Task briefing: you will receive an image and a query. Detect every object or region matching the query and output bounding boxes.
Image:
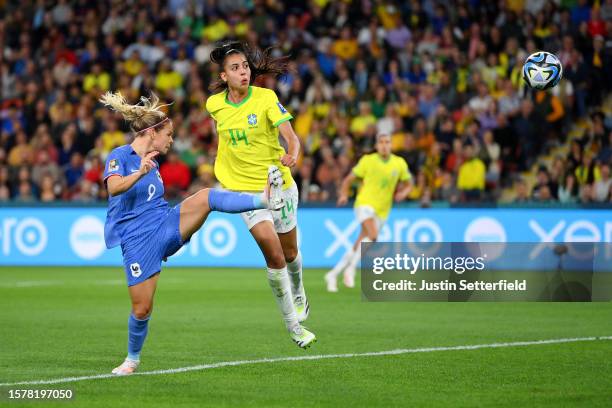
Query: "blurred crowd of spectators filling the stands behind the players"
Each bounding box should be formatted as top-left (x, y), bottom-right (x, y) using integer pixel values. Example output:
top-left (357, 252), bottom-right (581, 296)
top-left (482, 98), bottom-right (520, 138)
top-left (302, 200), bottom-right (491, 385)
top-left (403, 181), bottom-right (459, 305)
top-left (0, 0), bottom-right (612, 205)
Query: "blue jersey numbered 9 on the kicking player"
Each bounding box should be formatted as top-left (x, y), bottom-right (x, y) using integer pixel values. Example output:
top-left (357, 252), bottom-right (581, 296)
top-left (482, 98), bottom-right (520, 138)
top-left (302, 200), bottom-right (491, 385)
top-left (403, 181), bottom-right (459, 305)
top-left (104, 145), bottom-right (169, 248)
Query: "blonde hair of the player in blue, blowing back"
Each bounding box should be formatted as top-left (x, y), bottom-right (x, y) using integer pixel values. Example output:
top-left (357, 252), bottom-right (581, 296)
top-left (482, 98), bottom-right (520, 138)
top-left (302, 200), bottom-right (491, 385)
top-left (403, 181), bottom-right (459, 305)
top-left (100, 92), bottom-right (169, 133)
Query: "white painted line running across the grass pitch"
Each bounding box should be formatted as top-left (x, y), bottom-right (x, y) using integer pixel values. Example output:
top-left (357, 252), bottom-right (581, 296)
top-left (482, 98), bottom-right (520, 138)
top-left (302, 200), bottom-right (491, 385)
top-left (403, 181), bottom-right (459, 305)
top-left (0, 336), bottom-right (612, 387)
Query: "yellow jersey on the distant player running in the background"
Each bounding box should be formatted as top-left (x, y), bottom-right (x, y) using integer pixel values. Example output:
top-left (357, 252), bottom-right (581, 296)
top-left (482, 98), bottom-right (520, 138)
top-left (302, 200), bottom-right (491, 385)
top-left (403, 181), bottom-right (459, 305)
top-left (353, 153), bottom-right (412, 219)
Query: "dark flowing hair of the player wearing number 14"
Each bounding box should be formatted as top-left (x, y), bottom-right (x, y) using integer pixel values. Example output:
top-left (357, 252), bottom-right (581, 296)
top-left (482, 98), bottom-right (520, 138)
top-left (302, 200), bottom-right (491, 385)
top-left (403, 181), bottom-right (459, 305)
top-left (208, 41), bottom-right (289, 93)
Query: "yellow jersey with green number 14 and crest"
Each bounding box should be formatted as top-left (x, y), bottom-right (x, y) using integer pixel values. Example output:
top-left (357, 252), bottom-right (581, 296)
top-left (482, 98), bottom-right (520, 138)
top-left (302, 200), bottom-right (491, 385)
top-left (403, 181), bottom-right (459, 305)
top-left (206, 86), bottom-right (294, 191)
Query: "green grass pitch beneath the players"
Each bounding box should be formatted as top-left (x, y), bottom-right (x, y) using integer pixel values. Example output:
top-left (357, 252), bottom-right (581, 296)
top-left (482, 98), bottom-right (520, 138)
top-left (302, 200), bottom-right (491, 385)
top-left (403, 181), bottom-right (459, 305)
top-left (0, 268), bottom-right (612, 407)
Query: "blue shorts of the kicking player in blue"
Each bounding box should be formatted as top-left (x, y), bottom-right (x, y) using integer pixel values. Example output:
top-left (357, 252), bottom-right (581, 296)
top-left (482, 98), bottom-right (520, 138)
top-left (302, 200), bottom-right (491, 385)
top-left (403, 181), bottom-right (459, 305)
top-left (121, 204), bottom-right (185, 286)
